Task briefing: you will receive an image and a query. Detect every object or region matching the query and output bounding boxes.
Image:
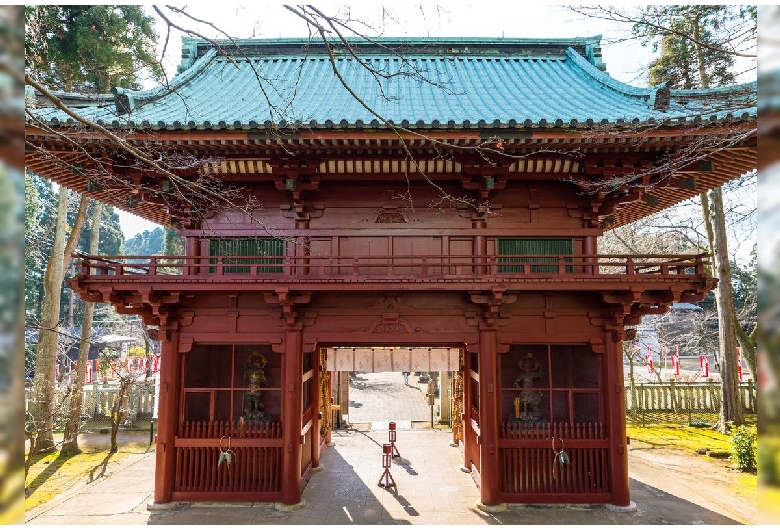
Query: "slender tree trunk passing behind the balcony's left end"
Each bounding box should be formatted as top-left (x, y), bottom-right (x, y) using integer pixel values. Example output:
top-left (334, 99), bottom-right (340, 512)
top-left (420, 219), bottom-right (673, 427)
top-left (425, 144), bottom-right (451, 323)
top-left (61, 202), bottom-right (103, 453)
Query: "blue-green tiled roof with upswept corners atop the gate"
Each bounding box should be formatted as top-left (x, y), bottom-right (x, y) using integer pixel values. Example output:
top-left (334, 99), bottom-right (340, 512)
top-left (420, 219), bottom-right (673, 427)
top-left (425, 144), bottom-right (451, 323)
top-left (29, 37), bottom-right (756, 130)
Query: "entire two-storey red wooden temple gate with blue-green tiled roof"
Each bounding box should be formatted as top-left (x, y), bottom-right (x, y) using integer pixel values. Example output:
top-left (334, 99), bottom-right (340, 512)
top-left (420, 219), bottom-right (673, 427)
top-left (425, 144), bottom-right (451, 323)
top-left (27, 39), bottom-right (756, 507)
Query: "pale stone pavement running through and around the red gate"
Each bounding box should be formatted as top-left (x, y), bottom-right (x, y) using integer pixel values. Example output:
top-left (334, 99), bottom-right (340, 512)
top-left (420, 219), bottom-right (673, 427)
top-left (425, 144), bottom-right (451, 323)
top-left (25, 374), bottom-right (754, 526)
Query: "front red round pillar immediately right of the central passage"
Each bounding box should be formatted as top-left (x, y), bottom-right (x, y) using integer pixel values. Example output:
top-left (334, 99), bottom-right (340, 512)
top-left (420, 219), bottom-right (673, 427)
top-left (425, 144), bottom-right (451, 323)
top-left (478, 329), bottom-right (501, 506)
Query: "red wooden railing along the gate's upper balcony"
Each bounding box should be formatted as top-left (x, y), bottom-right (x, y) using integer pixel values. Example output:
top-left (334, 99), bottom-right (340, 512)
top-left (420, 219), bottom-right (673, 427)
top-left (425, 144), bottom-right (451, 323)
top-left (70, 254), bottom-right (709, 283)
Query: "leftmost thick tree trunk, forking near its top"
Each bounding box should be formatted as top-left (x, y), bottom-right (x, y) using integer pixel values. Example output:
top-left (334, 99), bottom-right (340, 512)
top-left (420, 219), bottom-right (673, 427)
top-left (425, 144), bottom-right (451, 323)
top-left (31, 187), bottom-right (88, 453)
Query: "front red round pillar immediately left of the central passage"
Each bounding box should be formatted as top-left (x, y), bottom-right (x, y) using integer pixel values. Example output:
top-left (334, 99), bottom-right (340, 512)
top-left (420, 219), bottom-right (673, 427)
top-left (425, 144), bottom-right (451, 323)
top-left (282, 330), bottom-right (303, 504)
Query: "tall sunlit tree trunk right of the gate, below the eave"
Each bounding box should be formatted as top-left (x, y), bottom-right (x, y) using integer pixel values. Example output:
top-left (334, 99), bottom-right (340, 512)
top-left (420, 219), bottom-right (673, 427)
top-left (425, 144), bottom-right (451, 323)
top-left (702, 187), bottom-right (744, 433)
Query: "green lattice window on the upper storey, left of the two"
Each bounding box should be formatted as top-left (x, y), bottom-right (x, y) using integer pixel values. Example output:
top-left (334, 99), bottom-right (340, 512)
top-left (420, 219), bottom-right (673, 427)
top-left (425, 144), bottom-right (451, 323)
top-left (209, 237), bottom-right (284, 274)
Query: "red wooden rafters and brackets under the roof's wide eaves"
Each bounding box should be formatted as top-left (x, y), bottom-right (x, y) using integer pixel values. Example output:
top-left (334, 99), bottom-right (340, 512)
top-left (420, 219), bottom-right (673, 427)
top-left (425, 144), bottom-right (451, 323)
top-left (26, 122), bottom-right (757, 229)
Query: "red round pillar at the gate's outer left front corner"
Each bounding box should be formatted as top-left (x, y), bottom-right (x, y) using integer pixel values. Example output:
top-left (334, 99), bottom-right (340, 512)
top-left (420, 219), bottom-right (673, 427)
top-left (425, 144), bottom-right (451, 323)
top-left (154, 331), bottom-right (182, 504)
